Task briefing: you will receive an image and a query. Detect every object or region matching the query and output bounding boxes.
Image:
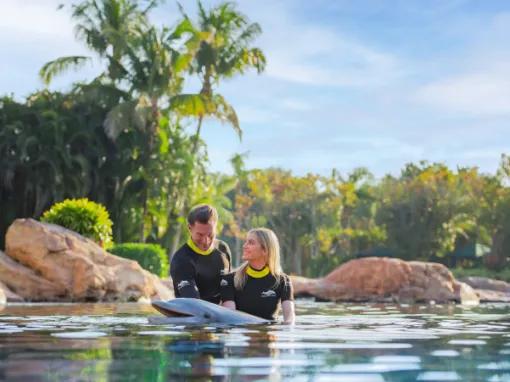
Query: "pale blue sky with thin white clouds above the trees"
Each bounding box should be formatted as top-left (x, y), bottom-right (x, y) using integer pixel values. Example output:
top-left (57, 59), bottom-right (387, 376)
top-left (0, 0), bottom-right (510, 177)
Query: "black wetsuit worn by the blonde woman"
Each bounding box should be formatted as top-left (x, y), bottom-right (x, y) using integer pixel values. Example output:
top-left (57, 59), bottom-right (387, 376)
top-left (221, 273), bottom-right (294, 320)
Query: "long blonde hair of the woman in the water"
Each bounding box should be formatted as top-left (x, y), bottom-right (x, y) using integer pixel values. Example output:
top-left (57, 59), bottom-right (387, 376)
top-left (234, 228), bottom-right (283, 290)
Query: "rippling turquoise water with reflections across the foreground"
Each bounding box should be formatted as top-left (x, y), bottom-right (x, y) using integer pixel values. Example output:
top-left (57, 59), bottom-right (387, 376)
top-left (0, 300), bottom-right (510, 382)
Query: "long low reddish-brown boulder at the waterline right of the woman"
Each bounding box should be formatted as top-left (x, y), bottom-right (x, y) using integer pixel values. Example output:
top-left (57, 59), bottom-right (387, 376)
top-left (291, 257), bottom-right (479, 304)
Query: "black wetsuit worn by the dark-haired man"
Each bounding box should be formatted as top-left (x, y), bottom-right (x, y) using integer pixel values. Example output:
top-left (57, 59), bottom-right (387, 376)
top-left (170, 240), bottom-right (230, 304)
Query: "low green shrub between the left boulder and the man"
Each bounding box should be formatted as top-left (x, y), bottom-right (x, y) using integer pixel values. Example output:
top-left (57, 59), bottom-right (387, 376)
top-left (109, 243), bottom-right (169, 277)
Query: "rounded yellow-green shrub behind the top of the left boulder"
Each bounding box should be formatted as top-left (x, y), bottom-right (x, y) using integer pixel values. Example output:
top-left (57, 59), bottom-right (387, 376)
top-left (41, 198), bottom-right (112, 248)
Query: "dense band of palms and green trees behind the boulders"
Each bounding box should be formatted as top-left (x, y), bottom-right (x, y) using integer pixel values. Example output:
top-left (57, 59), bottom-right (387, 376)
top-left (0, 0), bottom-right (510, 276)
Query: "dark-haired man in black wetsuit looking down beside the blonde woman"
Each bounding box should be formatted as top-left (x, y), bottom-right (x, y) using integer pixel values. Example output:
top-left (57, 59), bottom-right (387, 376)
top-left (170, 204), bottom-right (230, 304)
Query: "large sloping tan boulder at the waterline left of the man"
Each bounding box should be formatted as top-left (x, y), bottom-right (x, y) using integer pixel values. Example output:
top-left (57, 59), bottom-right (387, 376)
top-left (0, 219), bottom-right (173, 301)
